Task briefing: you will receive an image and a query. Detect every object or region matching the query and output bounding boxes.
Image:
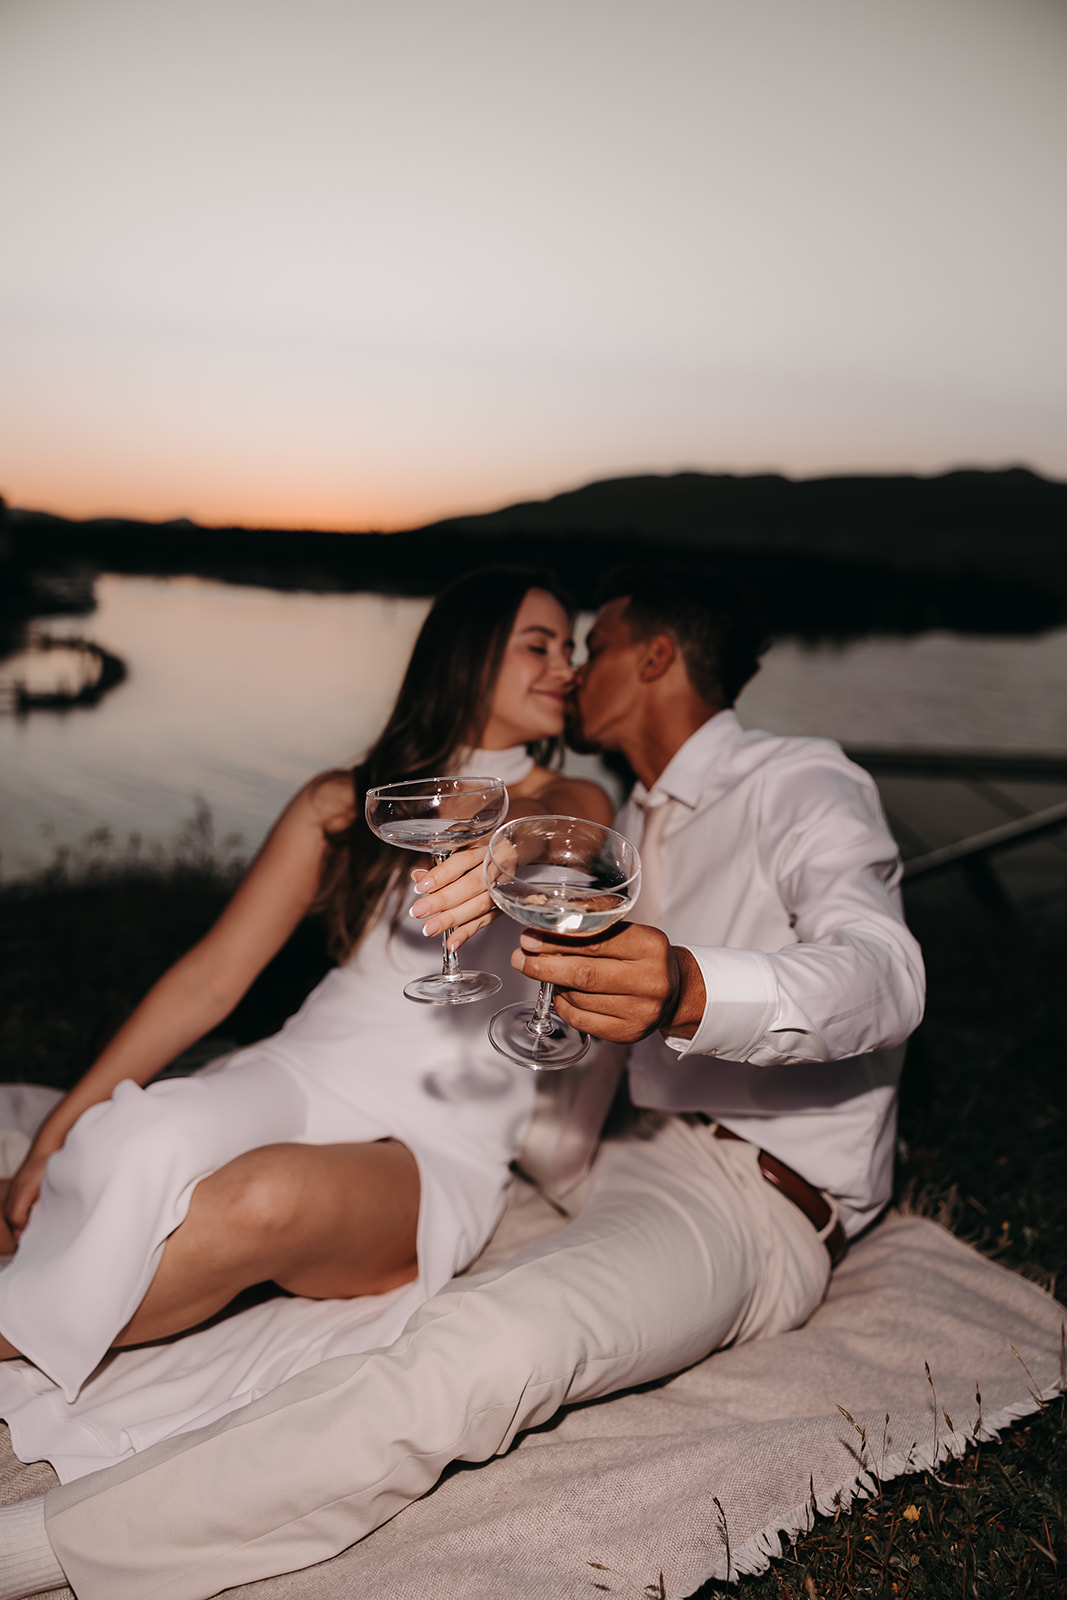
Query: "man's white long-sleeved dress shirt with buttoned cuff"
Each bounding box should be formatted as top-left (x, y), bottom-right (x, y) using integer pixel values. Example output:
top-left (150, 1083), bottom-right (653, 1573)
top-left (616, 710), bottom-right (925, 1234)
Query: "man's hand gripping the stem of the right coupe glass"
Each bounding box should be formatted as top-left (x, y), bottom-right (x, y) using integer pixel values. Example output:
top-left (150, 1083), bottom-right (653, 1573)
top-left (512, 922), bottom-right (705, 1043)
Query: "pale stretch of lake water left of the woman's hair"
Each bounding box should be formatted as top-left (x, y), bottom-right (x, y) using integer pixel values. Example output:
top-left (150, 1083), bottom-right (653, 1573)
top-left (0, 576), bottom-right (429, 877)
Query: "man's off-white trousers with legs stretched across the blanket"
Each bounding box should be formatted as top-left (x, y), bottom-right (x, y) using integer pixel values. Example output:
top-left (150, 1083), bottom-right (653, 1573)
top-left (46, 1118), bottom-right (830, 1600)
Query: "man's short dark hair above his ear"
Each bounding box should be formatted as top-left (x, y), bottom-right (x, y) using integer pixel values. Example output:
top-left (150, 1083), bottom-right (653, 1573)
top-left (600, 565), bottom-right (771, 706)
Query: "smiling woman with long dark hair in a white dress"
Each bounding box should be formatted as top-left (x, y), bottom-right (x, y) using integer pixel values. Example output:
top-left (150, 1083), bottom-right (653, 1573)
top-left (0, 568), bottom-right (611, 1470)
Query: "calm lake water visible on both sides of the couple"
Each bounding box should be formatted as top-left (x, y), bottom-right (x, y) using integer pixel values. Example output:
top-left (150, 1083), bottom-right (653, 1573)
top-left (0, 576), bottom-right (1067, 878)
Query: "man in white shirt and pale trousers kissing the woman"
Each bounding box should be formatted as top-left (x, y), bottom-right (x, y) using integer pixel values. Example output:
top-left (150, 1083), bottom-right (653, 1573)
top-left (0, 573), bottom-right (923, 1600)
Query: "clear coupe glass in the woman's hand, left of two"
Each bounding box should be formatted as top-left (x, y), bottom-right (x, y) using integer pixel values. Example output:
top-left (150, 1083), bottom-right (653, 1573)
top-left (366, 778), bottom-right (507, 1005)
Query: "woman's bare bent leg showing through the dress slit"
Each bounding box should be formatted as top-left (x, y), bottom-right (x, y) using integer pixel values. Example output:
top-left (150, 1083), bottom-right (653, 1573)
top-left (115, 1139), bottom-right (419, 1346)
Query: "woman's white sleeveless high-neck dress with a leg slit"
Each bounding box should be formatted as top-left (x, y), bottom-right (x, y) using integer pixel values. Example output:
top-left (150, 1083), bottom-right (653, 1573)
top-left (0, 752), bottom-right (534, 1482)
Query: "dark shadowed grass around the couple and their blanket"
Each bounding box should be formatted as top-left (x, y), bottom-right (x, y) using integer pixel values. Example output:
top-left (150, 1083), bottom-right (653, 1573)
top-left (0, 832), bottom-right (1067, 1600)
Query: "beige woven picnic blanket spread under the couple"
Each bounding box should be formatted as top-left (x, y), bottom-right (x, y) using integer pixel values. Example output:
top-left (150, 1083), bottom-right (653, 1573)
top-left (0, 1190), bottom-right (1067, 1600)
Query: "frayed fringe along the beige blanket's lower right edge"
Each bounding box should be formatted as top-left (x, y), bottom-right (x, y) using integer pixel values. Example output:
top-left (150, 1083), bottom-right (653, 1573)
top-left (665, 1379), bottom-right (1067, 1600)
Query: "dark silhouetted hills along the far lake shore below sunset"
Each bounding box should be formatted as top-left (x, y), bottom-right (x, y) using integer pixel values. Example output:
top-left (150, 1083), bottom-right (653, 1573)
top-left (0, 467), bottom-right (1067, 638)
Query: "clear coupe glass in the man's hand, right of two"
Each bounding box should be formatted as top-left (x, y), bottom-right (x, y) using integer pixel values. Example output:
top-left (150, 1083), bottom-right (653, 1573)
top-left (485, 816), bottom-right (641, 1072)
